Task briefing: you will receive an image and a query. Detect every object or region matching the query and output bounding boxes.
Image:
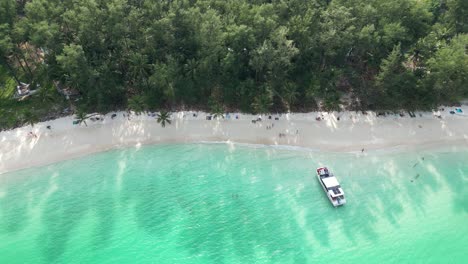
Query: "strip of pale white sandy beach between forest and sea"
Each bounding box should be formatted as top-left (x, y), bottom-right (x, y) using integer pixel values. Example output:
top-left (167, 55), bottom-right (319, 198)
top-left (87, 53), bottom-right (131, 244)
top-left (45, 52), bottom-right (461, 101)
top-left (0, 107), bottom-right (468, 173)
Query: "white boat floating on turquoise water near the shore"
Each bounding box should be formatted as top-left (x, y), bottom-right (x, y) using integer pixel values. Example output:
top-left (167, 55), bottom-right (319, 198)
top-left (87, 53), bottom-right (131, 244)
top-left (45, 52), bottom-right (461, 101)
top-left (317, 167), bottom-right (346, 207)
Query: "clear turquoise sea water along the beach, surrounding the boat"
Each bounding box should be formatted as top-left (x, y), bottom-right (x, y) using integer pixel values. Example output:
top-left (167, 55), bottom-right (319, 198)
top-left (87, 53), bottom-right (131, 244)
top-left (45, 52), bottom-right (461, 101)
top-left (0, 144), bottom-right (468, 264)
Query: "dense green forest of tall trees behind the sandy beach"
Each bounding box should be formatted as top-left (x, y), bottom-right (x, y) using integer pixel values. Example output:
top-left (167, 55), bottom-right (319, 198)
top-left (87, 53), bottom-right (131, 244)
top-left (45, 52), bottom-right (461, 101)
top-left (0, 0), bottom-right (468, 127)
